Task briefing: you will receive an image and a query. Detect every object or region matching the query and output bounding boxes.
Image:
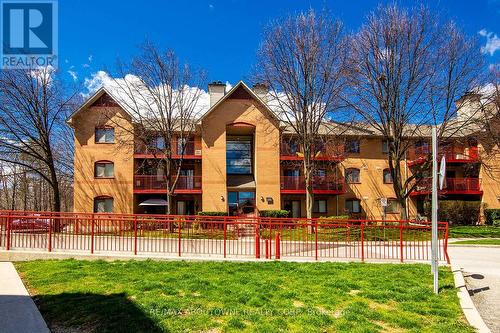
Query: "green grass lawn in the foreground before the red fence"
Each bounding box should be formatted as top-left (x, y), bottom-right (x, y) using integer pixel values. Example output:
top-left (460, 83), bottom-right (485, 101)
top-left (16, 260), bottom-right (473, 332)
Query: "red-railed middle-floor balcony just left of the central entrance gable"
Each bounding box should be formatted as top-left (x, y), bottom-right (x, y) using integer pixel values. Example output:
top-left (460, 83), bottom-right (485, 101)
top-left (134, 175), bottom-right (201, 194)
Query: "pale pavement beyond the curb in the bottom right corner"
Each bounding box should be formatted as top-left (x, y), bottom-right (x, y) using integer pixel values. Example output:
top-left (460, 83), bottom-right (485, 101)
top-left (448, 245), bottom-right (500, 332)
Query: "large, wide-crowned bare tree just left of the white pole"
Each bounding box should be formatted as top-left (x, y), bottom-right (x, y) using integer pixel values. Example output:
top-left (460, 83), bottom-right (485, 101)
top-left (345, 5), bottom-right (482, 219)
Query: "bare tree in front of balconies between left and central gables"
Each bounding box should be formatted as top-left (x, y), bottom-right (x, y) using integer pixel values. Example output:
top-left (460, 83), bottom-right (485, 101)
top-left (103, 42), bottom-right (205, 214)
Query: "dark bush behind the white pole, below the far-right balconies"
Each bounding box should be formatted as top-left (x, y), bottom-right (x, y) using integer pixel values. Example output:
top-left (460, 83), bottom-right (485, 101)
top-left (425, 200), bottom-right (481, 225)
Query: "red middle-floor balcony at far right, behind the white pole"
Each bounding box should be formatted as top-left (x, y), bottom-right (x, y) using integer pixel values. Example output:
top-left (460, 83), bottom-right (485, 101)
top-left (410, 178), bottom-right (483, 196)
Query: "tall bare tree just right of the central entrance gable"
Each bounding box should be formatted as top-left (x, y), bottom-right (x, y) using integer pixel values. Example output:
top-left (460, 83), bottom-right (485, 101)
top-left (255, 10), bottom-right (347, 218)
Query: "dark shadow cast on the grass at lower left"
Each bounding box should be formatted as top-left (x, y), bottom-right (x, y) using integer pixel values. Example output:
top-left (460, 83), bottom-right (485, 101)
top-left (33, 293), bottom-right (164, 333)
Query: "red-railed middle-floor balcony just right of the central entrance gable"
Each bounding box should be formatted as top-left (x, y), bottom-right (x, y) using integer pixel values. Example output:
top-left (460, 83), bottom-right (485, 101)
top-left (281, 176), bottom-right (346, 194)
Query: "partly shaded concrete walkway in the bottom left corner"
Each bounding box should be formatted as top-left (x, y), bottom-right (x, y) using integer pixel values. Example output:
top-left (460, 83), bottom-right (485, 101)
top-left (0, 262), bottom-right (50, 333)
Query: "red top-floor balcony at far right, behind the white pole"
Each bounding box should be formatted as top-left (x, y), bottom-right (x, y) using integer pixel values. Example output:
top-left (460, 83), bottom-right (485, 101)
top-left (408, 146), bottom-right (479, 166)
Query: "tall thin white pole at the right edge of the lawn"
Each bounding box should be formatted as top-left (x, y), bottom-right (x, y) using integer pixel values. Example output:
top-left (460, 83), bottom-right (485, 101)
top-left (432, 127), bottom-right (439, 294)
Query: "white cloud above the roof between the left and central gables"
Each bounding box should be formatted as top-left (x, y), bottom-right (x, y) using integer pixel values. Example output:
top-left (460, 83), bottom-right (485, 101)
top-left (81, 71), bottom-right (210, 117)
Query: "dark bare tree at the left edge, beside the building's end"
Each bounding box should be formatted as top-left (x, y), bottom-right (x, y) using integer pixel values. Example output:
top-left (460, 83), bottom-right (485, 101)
top-left (0, 67), bottom-right (73, 211)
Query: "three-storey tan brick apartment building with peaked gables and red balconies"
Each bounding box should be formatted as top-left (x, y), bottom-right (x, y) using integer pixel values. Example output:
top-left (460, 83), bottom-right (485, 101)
top-left (68, 81), bottom-right (500, 219)
